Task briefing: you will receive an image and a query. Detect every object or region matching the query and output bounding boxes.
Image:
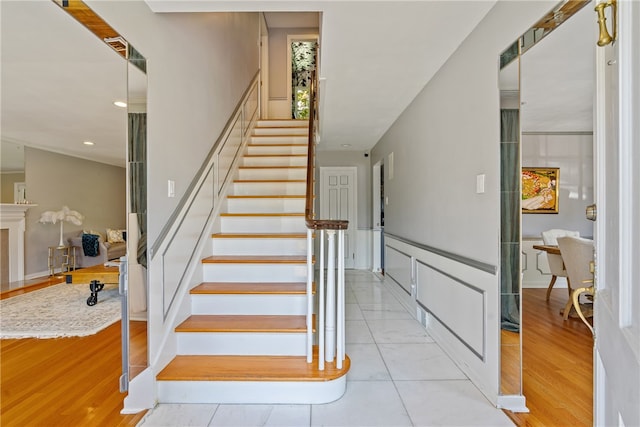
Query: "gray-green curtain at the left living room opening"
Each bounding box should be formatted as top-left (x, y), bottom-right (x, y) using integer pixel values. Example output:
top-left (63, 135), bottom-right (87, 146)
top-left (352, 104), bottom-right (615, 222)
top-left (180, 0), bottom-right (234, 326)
top-left (129, 113), bottom-right (147, 268)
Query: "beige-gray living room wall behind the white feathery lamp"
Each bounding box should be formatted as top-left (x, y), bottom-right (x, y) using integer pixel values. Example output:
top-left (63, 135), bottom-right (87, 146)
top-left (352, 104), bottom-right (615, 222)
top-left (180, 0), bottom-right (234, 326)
top-left (25, 147), bottom-right (126, 277)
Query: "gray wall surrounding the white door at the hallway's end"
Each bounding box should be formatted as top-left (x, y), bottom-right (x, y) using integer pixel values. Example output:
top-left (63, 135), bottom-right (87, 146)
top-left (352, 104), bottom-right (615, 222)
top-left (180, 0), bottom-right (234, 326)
top-left (316, 150), bottom-right (372, 229)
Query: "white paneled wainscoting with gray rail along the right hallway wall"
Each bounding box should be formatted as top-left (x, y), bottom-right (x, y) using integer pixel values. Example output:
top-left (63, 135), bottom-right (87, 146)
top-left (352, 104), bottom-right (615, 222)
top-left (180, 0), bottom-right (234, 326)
top-left (384, 234), bottom-right (500, 404)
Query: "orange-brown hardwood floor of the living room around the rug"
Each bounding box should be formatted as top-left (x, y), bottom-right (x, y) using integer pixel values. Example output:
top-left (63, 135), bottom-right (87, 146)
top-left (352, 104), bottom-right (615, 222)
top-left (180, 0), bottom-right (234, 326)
top-left (0, 284), bottom-right (146, 427)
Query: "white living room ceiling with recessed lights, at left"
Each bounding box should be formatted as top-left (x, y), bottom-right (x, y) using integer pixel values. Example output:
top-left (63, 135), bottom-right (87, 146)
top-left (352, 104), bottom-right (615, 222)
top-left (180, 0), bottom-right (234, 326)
top-left (0, 0), bottom-right (127, 171)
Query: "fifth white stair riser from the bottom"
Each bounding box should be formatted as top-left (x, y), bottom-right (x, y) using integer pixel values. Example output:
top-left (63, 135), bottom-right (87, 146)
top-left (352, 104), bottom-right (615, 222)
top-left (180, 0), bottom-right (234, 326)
top-left (213, 237), bottom-right (307, 255)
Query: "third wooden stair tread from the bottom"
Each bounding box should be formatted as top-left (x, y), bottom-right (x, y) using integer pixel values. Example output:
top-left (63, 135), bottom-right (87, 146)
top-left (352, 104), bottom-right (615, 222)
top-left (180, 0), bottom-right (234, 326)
top-left (190, 282), bottom-right (315, 295)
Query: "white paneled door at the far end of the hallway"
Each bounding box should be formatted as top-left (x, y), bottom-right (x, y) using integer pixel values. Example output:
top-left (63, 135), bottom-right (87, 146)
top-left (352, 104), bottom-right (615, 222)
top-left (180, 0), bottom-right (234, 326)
top-left (320, 167), bottom-right (358, 268)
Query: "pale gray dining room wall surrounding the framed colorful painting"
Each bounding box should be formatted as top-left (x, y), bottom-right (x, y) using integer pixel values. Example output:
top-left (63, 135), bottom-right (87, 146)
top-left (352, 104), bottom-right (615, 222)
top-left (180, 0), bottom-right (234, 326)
top-left (521, 133), bottom-right (593, 237)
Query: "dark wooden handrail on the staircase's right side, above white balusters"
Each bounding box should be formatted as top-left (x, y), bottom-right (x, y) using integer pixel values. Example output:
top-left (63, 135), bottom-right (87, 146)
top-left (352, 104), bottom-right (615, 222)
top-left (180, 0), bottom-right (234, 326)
top-left (304, 71), bottom-right (349, 230)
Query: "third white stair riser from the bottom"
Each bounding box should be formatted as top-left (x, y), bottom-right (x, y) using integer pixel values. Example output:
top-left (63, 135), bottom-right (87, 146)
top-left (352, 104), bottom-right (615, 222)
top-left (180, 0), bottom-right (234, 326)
top-left (191, 294), bottom-right (307, 316)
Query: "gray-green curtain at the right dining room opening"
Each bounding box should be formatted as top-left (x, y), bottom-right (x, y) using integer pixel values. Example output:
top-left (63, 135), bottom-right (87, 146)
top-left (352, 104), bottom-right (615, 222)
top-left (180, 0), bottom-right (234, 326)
top-left (500, 109), bottom-right (521, 332)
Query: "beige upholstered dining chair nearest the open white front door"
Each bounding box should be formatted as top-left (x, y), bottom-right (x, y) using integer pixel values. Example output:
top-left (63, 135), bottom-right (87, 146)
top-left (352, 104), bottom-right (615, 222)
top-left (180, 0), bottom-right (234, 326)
top-left (558, 236), bottom-right (594, 333)
